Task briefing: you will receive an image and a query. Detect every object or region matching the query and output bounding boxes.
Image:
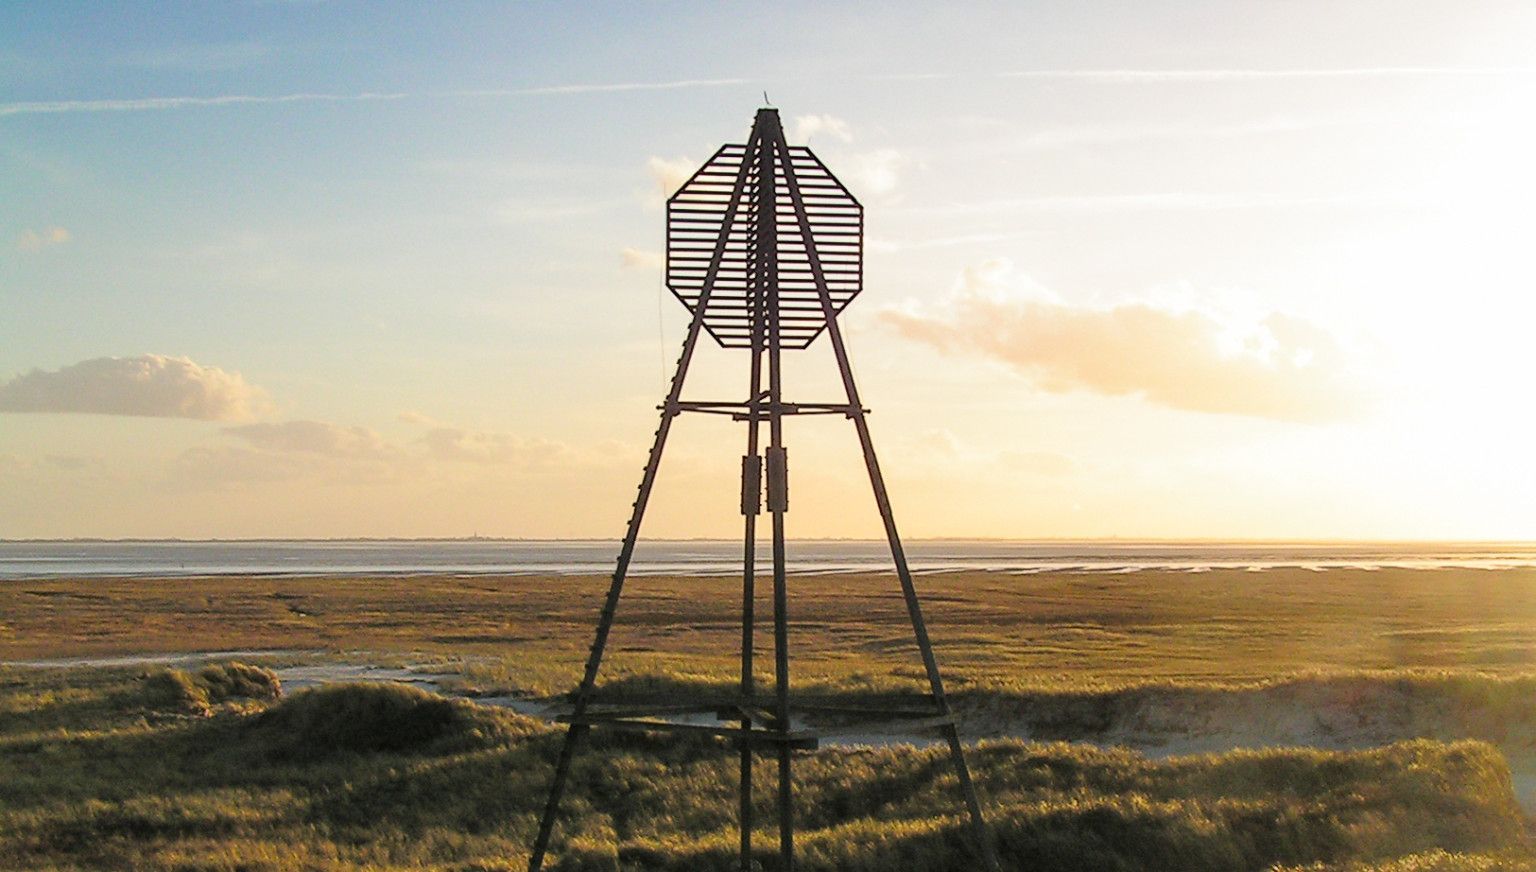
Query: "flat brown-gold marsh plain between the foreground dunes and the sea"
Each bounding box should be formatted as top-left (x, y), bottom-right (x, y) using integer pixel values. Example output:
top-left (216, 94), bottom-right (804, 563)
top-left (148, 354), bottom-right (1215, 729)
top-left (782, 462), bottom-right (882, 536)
top-left (9, 568), bottom-right (1536, 695)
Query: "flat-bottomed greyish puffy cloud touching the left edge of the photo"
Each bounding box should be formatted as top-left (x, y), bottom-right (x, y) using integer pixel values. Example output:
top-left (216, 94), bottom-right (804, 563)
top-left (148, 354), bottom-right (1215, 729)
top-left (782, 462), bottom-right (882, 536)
top-left (0, 355), bottom-right (266, 421)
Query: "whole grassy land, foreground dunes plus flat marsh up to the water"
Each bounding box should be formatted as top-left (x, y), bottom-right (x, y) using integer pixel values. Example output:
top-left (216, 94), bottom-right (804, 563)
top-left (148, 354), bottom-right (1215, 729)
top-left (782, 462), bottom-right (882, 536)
top-left (0, 570), bottom-right (1536, 872)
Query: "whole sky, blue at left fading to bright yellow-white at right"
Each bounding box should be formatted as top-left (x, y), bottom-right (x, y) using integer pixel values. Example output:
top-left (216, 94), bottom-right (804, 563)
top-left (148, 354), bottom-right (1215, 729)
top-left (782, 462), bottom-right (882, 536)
top-left (0, 0), bottom-right (1536, 539)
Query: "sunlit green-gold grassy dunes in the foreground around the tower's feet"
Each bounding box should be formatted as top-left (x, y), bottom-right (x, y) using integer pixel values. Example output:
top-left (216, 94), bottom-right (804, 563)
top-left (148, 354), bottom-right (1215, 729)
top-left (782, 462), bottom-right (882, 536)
top-left (0, 669), bottom-right (1528, 872)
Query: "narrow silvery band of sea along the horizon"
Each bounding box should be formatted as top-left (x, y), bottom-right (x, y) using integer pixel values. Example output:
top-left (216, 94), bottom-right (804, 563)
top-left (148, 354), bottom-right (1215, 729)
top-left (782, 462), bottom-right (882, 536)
top-left (0, 539), bottom-right (1536, 579)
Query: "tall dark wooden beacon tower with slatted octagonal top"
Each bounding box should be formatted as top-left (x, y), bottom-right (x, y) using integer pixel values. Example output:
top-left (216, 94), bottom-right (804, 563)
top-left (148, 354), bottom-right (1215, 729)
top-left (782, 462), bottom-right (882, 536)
top-left (528, 109), bottom-right (997, 872)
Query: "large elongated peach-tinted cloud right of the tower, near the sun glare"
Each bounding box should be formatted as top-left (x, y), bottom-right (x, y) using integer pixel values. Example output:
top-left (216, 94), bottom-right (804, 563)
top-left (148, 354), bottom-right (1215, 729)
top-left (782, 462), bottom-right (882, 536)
top-left (880, 261), bottom-right (1358, 421)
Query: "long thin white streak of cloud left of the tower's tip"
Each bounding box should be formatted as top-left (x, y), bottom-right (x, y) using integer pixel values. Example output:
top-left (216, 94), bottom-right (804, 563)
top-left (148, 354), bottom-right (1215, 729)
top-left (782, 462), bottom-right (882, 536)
top-left (0, 78), bottom-right (745, 117)
